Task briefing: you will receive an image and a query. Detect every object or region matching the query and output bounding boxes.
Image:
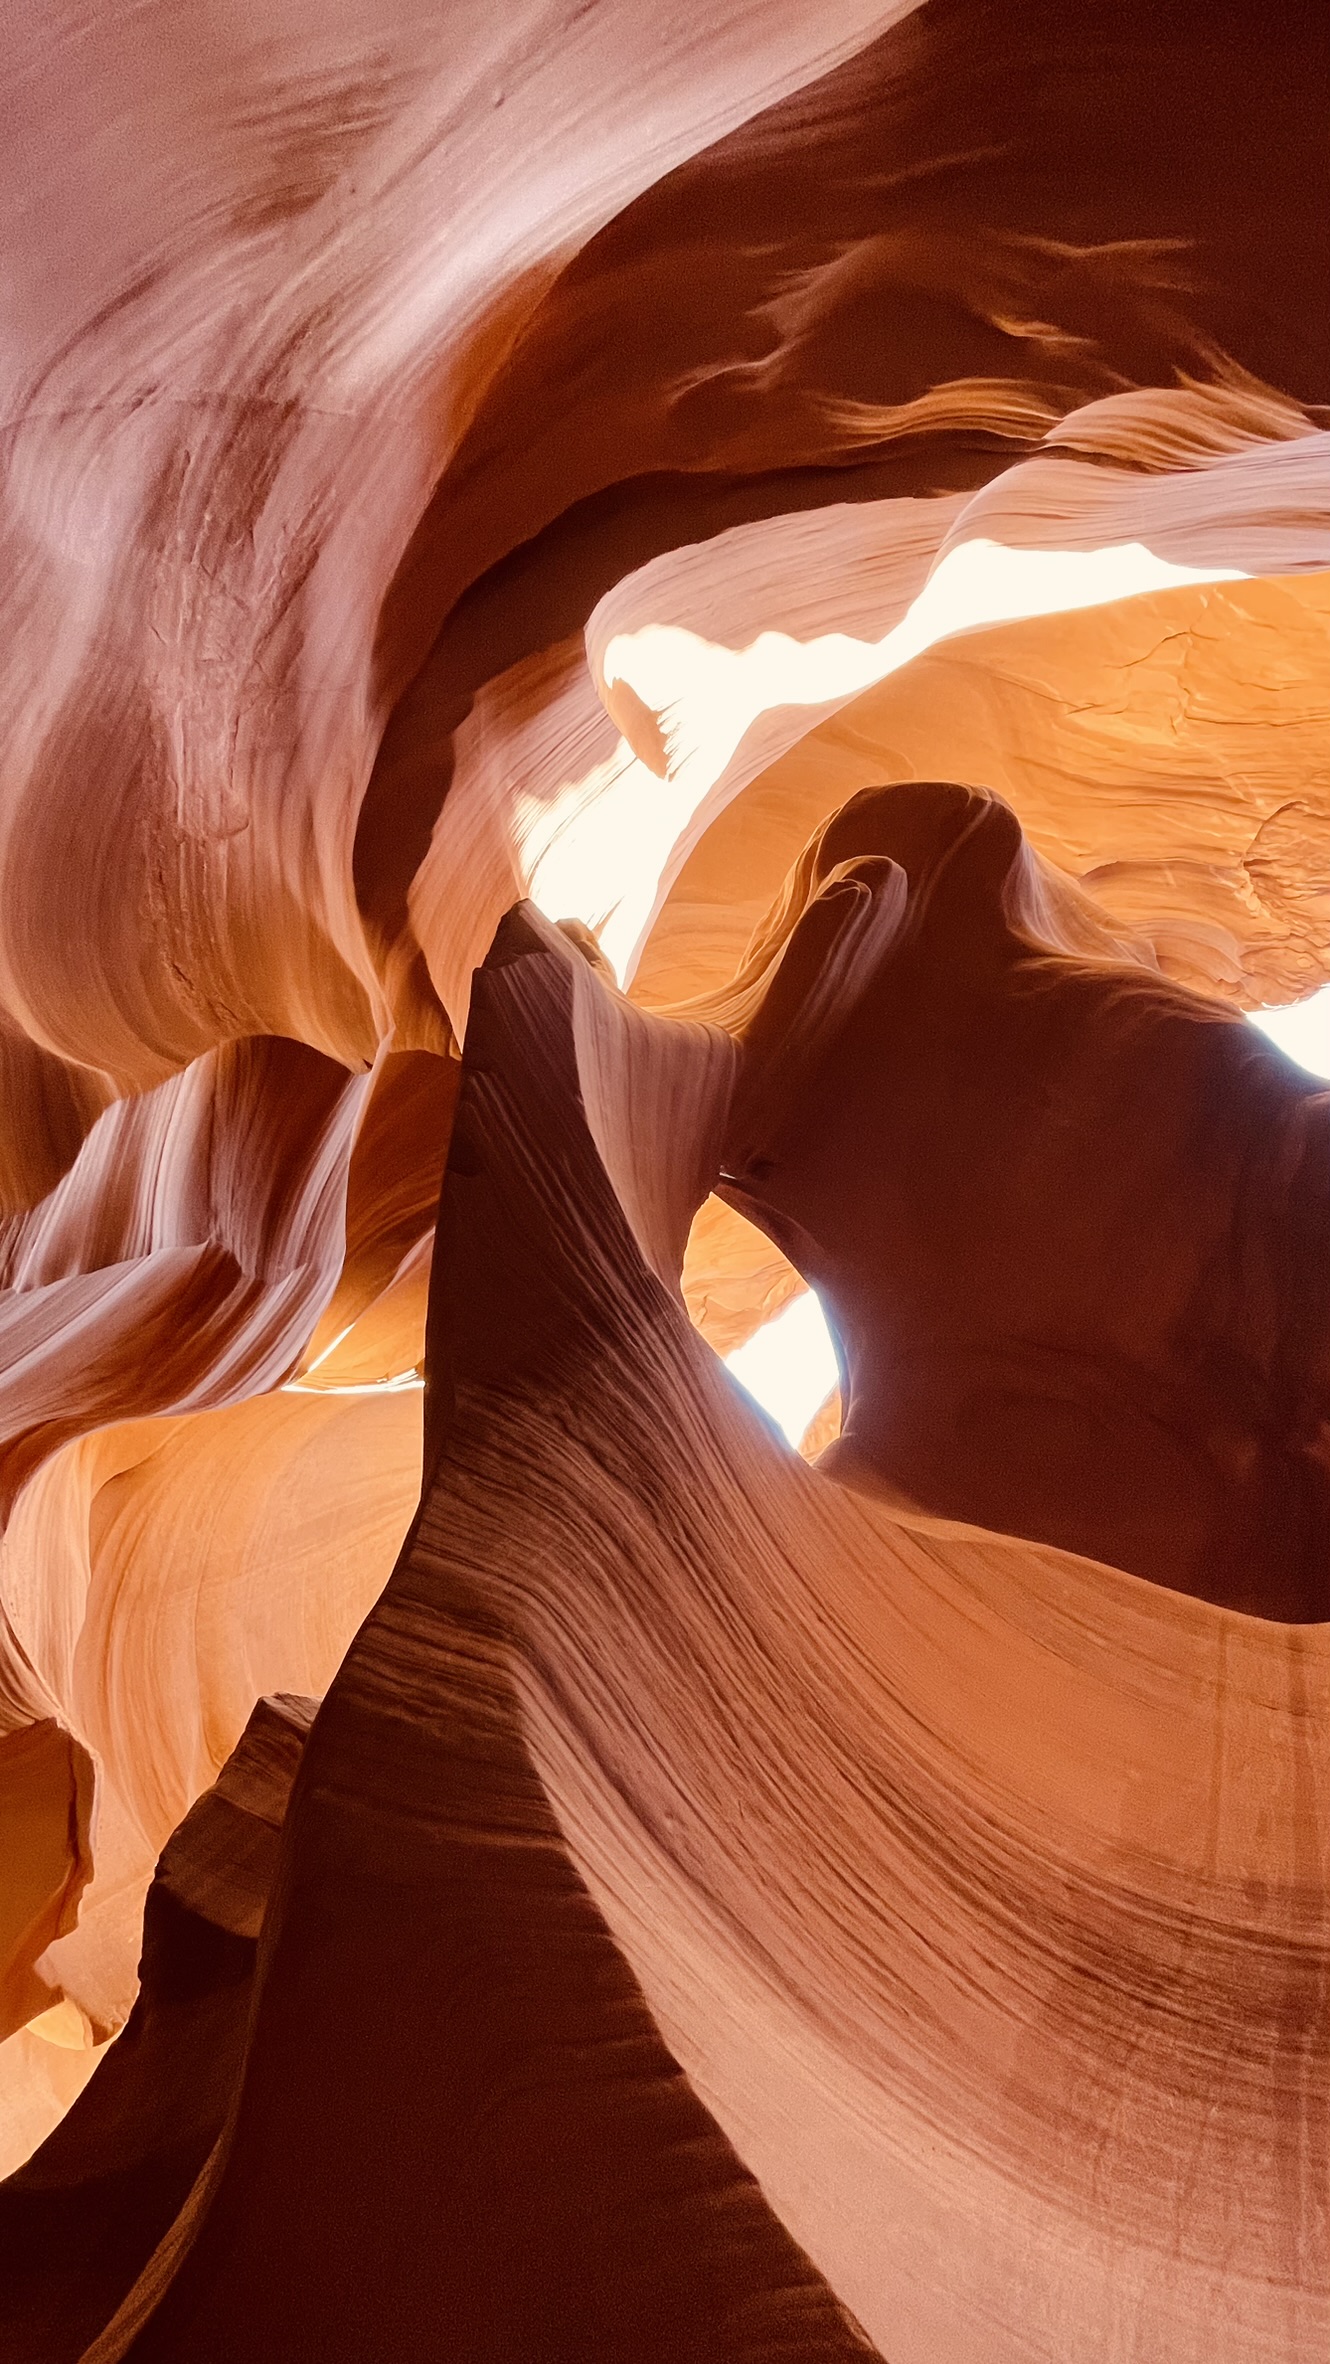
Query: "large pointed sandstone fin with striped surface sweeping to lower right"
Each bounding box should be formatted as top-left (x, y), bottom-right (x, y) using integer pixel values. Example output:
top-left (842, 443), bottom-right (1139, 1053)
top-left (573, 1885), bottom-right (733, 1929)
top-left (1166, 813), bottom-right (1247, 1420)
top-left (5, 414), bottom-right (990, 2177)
top-left (64, 915), bottom-right (1330, 2359)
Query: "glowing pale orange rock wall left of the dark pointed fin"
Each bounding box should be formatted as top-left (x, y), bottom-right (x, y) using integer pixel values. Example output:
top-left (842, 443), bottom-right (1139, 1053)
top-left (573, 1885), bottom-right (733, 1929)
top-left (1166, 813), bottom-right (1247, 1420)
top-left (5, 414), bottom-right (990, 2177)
top-left (0, 1392), bottom-right (420, 2051)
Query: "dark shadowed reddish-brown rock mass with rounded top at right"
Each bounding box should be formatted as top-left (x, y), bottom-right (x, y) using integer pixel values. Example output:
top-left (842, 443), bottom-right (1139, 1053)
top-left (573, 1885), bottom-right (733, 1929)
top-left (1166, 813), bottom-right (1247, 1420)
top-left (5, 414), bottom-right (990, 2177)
top-left (725, 782), bottom-right (1330, 1622)
